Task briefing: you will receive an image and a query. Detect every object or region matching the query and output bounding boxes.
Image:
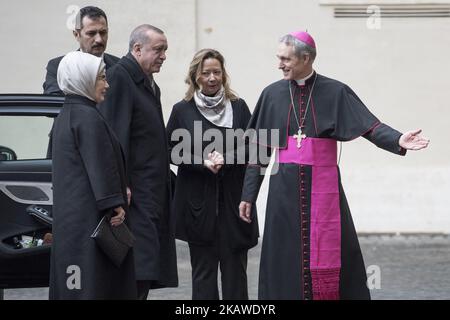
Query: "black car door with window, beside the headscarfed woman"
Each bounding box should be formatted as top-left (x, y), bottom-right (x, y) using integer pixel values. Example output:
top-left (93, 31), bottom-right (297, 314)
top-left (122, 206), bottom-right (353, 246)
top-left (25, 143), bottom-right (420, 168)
top-left (0, 95), bottom-right (63, 288)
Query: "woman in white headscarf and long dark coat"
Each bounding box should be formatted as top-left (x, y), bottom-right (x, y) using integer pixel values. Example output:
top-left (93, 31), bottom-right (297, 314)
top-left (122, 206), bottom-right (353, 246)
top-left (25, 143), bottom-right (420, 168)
top-left (49, 51), bottom-right (136, 299)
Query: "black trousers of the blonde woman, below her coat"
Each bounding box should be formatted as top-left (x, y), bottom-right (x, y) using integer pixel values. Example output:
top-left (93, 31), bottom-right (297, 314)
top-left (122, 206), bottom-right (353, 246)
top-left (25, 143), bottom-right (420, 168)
top-left (189, 243), bottom-right (248, 300)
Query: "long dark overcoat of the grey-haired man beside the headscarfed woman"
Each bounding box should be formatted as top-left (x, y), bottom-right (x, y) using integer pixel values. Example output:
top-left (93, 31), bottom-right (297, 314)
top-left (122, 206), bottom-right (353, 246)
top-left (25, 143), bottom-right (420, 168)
top-left (99, 53), bottom-right (178, 288)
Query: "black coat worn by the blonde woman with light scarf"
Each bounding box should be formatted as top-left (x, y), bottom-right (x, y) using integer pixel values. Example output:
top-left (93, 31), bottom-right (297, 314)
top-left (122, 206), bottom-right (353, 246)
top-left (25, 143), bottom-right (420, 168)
top-left (167, 99), bottom-right (259, 250)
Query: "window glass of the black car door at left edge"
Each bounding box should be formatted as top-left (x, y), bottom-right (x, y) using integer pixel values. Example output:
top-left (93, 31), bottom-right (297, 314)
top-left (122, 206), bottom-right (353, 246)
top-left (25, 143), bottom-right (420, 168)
top-left (0, 115), bottom-right (53, 161)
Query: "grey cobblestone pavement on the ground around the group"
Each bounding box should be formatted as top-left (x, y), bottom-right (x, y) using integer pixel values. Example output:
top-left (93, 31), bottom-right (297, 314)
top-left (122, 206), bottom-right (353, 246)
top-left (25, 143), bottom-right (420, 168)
top-left (4, 235), bottom-right (450, 300)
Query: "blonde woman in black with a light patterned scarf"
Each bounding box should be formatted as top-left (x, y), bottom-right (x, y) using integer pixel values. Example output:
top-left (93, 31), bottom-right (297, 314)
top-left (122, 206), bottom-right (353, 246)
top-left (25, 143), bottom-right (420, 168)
top-left (167, 49), bottom-right (258, 300)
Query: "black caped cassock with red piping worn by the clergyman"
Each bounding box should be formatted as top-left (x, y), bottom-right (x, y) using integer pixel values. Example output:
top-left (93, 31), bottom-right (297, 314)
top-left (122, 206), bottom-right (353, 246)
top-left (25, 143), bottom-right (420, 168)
top-left (242, 73), bottom-right (406, 299)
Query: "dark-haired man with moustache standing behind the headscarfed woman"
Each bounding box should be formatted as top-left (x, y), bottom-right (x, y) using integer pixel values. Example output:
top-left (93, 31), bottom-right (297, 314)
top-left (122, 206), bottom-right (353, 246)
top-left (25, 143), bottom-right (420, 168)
top-left (43, 6), bottom-right (119, 95)
